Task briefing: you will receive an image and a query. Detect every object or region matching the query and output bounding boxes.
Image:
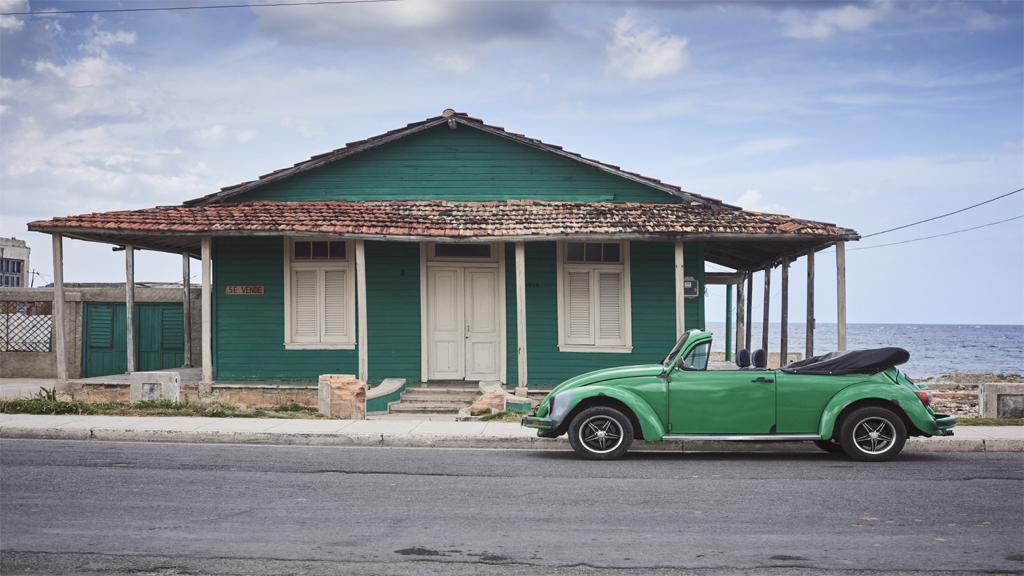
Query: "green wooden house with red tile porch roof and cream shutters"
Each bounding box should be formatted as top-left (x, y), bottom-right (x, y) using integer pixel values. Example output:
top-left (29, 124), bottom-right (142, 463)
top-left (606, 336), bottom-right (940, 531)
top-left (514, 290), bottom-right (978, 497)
top-left (30, 111), bottom-right (856, 387)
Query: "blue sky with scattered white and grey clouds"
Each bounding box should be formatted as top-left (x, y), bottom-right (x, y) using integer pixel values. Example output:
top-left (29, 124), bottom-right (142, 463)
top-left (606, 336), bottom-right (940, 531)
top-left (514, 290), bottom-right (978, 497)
top-left (0, 0), bottom-right (1024, 324)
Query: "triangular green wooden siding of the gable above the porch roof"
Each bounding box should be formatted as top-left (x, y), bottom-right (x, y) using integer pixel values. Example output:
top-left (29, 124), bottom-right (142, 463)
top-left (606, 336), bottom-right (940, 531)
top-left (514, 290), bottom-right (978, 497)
top-left (228, 126), bottom-right (682, 204)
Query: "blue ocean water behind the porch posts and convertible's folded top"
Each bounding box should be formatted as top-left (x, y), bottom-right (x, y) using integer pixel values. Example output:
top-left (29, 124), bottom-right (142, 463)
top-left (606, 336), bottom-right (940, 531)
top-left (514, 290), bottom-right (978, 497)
top-left (708, 322), bottom-right (1024, 378)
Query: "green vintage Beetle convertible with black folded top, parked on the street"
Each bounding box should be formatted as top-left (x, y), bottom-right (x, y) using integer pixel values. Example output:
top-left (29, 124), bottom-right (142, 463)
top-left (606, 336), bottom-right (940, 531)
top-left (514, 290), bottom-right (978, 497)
top-left (522, 330), bottom-right (956, 461)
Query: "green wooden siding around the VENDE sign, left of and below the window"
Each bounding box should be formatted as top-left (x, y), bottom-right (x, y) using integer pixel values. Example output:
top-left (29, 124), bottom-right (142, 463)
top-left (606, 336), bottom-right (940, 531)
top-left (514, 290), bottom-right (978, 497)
top-left (213, 237), bottom-right (358, 380)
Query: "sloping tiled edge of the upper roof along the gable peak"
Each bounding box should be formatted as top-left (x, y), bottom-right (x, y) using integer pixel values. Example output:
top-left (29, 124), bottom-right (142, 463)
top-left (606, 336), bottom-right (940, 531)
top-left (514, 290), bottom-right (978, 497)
top-left (183, 110), bottom-right (738, 209)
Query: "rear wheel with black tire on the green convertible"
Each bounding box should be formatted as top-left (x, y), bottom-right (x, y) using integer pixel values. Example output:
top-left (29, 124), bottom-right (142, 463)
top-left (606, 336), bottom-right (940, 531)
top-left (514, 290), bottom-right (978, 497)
top-left (840, 406), bottom-right (906, 462)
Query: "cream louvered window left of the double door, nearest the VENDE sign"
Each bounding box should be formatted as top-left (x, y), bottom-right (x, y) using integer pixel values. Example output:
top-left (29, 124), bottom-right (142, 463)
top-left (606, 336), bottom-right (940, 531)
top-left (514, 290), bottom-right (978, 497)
top-left (285, 240), bottom-right (355, 348)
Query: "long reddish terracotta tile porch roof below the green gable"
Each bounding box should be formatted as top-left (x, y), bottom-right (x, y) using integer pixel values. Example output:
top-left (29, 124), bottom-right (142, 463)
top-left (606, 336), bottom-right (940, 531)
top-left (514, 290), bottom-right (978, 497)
top-left (29, 200), bottom-right (856, 240)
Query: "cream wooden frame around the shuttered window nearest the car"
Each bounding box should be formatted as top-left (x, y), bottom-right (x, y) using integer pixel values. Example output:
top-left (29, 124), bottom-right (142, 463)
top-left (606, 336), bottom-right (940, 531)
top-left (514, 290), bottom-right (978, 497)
top-left (555, 240), bottom-right (633, 354)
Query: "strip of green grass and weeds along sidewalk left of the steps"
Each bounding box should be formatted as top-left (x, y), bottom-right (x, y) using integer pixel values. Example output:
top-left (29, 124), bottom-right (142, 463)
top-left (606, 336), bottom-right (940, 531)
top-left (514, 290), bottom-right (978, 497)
top-left (0, 388), bottom-right (328, 419)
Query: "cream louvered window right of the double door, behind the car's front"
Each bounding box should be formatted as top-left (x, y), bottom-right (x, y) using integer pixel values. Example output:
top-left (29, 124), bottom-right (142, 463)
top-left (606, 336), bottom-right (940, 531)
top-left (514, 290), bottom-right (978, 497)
top-left (558, 242), bottom-right (632, 353)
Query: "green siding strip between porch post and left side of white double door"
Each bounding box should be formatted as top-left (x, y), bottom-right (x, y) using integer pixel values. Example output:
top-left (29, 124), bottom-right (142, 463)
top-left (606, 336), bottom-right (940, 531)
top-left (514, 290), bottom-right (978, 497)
top-left (366, 241), bottom-right (421, 382)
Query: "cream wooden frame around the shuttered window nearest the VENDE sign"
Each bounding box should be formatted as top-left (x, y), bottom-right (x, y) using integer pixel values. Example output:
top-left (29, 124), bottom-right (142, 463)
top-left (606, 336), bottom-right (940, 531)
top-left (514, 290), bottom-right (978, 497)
top-left (284, 238), bottom-right (356, 349)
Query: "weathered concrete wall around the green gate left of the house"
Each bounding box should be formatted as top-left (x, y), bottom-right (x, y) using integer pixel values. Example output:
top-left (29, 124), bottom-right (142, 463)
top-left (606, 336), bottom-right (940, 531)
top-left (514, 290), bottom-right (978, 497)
top-left (0, 284), bottom-right (203, 378)
